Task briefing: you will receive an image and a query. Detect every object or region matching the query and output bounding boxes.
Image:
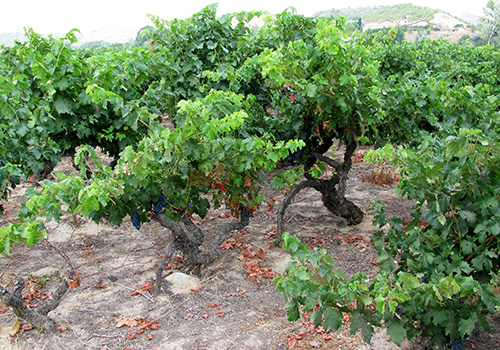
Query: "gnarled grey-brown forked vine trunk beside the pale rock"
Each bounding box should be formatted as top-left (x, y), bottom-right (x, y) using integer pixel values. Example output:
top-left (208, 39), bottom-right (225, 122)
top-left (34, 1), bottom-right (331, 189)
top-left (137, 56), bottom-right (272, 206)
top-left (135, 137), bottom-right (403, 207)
top-left (155, 213), bottom-right (245, 295)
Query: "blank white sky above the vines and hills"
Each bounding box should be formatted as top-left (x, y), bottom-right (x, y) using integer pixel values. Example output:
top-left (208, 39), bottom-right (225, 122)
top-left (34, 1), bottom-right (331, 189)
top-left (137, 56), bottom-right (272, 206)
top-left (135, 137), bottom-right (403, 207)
top-left (0, 0), bottom-right (487, 34)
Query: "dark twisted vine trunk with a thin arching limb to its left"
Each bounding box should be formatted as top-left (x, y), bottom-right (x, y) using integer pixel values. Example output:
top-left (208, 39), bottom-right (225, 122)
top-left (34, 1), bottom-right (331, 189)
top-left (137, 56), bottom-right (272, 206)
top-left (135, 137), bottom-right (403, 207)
top-left (278, 141), bottom-right (364, 239)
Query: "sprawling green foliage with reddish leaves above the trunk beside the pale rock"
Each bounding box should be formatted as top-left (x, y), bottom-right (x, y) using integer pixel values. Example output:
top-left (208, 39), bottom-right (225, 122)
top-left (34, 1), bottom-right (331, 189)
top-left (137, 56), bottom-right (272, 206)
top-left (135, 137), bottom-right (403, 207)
top-left (3, 91), bottom-right (303, 252)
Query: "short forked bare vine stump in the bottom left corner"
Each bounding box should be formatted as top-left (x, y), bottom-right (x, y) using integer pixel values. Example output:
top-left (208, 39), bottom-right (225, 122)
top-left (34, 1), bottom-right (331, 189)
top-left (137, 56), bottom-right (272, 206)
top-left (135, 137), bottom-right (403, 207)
top-left (0, 278), bottom-right (68, 333)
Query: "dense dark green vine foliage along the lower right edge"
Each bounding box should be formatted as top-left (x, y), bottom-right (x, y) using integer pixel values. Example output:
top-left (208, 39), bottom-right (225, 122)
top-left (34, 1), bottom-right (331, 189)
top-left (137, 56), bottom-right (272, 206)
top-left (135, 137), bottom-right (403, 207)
top-left (374, 129), bottom-right (500, 345)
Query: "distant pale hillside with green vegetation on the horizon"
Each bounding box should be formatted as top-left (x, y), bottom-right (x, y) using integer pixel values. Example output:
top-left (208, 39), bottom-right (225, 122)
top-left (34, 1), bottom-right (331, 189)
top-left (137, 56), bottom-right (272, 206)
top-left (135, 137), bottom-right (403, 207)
top-left (315, 4), bottom-right (439, 22)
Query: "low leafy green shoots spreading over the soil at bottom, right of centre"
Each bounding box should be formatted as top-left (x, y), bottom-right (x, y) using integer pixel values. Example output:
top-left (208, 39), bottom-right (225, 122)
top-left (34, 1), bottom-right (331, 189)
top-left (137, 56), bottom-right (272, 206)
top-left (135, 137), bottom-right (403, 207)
top-left (274, 232), bottom-right (380, 343)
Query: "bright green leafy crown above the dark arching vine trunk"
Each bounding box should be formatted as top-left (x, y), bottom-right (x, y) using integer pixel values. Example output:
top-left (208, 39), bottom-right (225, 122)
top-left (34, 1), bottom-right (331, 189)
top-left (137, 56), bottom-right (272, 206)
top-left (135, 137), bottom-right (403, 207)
top-left (238, 13), bottom-right (383, 164)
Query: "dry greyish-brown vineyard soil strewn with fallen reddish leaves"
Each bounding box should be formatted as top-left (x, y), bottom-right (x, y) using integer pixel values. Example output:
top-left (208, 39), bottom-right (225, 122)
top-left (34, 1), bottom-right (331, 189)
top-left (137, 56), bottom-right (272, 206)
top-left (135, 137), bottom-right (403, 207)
top-left (0, 146), bottom-right (500, 350)
